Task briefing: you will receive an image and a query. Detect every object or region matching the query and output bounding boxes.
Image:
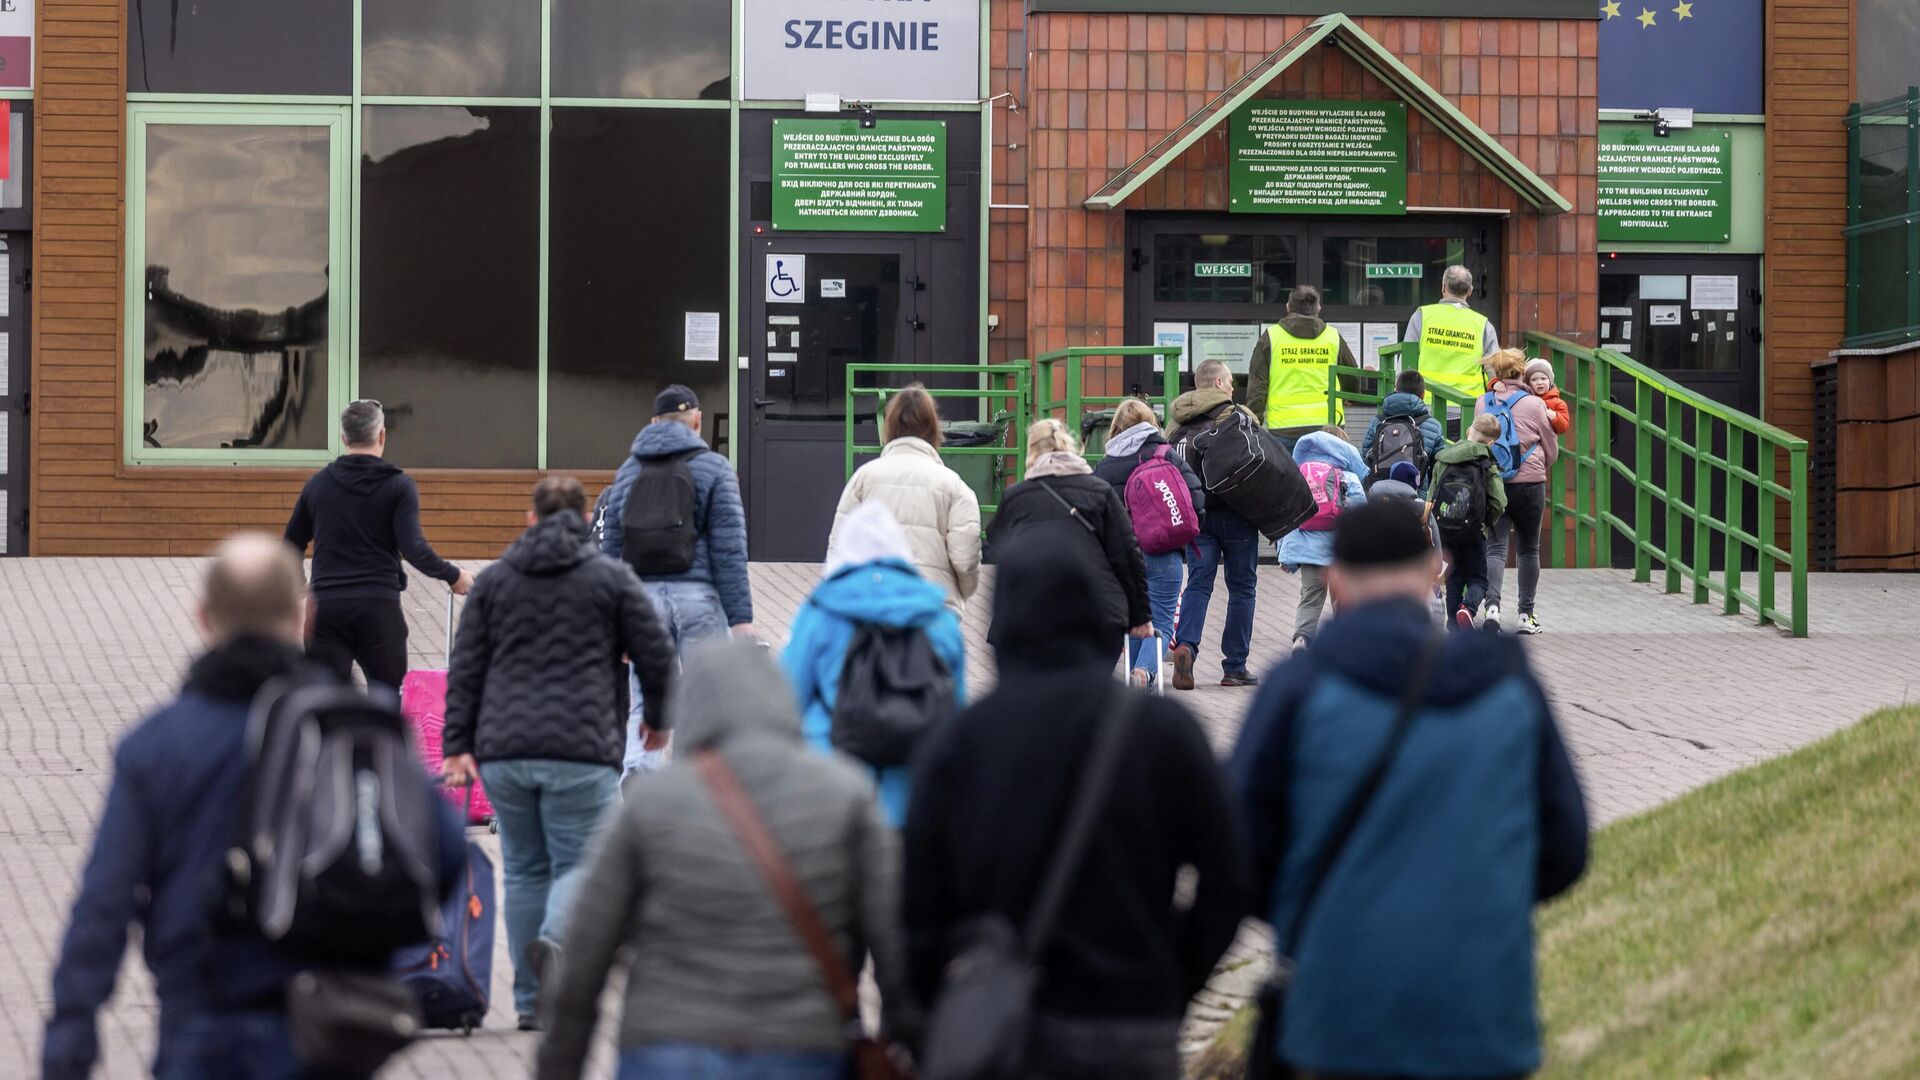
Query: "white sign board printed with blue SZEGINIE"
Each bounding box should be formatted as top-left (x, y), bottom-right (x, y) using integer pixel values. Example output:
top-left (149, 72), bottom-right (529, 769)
top-left (739, 0), bottom-right (979, 102)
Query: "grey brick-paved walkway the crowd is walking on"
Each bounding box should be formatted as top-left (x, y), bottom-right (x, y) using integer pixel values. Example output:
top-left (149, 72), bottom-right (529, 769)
top-left (0, 559), bottom-right (1920, 1078)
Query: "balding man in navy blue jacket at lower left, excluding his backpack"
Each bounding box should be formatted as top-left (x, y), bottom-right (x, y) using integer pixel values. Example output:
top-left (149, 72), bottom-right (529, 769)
top-left (40, 534), bottom-right (467, 1080)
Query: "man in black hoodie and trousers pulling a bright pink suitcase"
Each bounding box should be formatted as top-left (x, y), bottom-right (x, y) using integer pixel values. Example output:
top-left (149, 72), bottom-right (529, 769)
top-left (286, 402), bottom-right (474, 690)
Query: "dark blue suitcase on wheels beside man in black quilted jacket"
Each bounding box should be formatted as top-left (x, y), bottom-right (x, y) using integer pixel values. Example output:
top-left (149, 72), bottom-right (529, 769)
top-left (394, 840), bottom-right (499, 1034)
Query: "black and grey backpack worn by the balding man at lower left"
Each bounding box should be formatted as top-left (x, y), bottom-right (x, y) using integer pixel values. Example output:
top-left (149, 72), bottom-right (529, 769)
top-left (227, 678), bottom-right (442, 967)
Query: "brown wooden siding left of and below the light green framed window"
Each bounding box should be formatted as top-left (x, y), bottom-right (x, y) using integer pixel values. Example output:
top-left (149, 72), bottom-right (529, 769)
top-left (27, 0), bottom-right (591, 559)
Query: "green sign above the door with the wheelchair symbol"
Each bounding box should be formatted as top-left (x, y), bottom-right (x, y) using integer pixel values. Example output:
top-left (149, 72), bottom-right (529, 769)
top-left (774, 119), bottom-right (947, 233)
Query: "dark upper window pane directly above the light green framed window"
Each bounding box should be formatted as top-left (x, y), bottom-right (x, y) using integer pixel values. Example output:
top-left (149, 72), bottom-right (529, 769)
top-left (127, 0), bottom-right (353, 94)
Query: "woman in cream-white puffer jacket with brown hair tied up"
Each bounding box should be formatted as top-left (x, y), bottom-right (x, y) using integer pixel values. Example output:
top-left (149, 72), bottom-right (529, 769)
top-left (828, 384), bottom-right (979, 613)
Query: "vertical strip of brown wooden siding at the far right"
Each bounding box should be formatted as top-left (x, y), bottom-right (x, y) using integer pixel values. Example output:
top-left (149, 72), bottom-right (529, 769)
top-left (1763, 0), bottom-right (1855, 436)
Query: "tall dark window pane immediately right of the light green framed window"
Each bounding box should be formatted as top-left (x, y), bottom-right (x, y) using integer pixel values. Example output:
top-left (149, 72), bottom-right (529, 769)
top-left (359, 106), bottom-right (540, 469)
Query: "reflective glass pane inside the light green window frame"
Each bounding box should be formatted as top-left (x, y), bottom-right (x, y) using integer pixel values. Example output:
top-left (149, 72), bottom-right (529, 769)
top-left (136, 125), bottom-right (330, 450)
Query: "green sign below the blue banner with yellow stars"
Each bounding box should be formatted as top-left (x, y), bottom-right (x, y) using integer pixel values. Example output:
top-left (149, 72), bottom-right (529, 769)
top-left (1599, 127), bottom-right (1734, 244)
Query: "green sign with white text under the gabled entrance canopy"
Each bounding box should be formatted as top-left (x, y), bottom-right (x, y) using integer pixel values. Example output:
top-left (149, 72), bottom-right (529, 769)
top-left (1229, 102), bottom-right (1407, 213)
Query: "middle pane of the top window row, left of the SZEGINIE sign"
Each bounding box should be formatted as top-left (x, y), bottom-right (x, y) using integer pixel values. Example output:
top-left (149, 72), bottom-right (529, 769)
top-left (361, 0), bottom-right (540, 98)
